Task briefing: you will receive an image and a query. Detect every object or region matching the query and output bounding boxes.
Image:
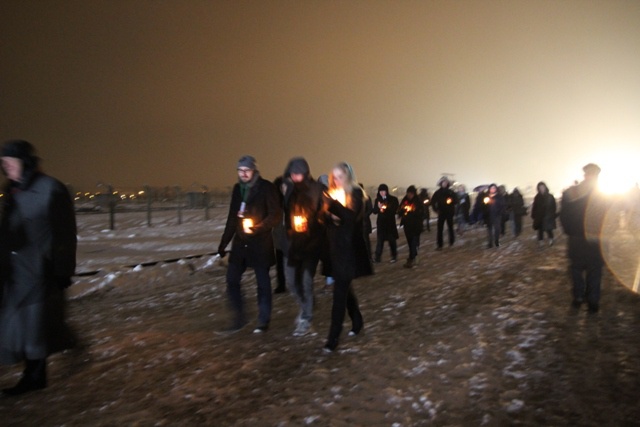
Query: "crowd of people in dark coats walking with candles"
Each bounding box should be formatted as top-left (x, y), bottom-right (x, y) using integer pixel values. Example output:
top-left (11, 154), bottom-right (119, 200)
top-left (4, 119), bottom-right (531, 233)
top-left (0, 141), bottom-right (620, 395)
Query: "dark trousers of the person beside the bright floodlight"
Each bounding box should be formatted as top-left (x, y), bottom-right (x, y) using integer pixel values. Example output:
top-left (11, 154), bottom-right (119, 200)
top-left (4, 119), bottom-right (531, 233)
top-left (568, 236), bottom-right (603, 306)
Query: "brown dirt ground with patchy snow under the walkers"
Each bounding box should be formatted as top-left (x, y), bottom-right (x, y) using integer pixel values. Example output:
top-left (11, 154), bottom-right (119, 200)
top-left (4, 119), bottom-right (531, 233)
top-left (0, 217), bottom-right (640, 427)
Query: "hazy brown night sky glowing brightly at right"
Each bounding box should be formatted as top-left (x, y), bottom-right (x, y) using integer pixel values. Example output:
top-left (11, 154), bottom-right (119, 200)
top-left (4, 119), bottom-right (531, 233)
top-left (0, 0), bottom-right (640, 192)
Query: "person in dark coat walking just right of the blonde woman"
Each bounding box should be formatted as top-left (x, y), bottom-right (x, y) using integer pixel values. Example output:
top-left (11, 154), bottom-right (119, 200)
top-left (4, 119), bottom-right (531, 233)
top-left (373, 184), bottom-right (400, 263)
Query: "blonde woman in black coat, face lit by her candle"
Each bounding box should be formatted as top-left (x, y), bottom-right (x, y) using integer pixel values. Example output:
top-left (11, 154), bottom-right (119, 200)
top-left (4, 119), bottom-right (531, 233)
top-left (324, 162), bottom-right (373, 352)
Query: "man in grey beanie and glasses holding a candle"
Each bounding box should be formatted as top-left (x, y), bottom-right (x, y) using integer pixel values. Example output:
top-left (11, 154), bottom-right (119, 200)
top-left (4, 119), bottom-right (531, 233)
top-left (218, 156), bottom-right (282, 333)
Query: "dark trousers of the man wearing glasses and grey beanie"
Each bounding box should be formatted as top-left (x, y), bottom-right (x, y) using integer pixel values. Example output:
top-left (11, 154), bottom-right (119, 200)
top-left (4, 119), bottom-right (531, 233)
top-left (227, 261), bottom-right (271, 325)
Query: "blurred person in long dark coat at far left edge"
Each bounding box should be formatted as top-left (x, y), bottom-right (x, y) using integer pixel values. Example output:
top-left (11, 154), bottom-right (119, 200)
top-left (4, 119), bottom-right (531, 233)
top-left (0, 140), bottom-right (77, 395)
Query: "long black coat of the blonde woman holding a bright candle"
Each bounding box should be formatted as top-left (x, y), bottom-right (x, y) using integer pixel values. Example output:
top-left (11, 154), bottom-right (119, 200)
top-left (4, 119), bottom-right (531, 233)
top-left (324, 188), bottom-right (373, 281)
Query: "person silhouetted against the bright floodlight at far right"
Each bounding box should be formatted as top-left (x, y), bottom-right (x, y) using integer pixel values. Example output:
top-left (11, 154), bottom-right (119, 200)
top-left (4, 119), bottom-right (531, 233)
top-left (560, 163), bottom-right (607, 313)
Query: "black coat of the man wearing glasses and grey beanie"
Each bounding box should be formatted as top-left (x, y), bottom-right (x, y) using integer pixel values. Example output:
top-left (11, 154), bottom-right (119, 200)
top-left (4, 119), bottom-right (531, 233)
top-left (220, 171), bottom-right (282, 268)
